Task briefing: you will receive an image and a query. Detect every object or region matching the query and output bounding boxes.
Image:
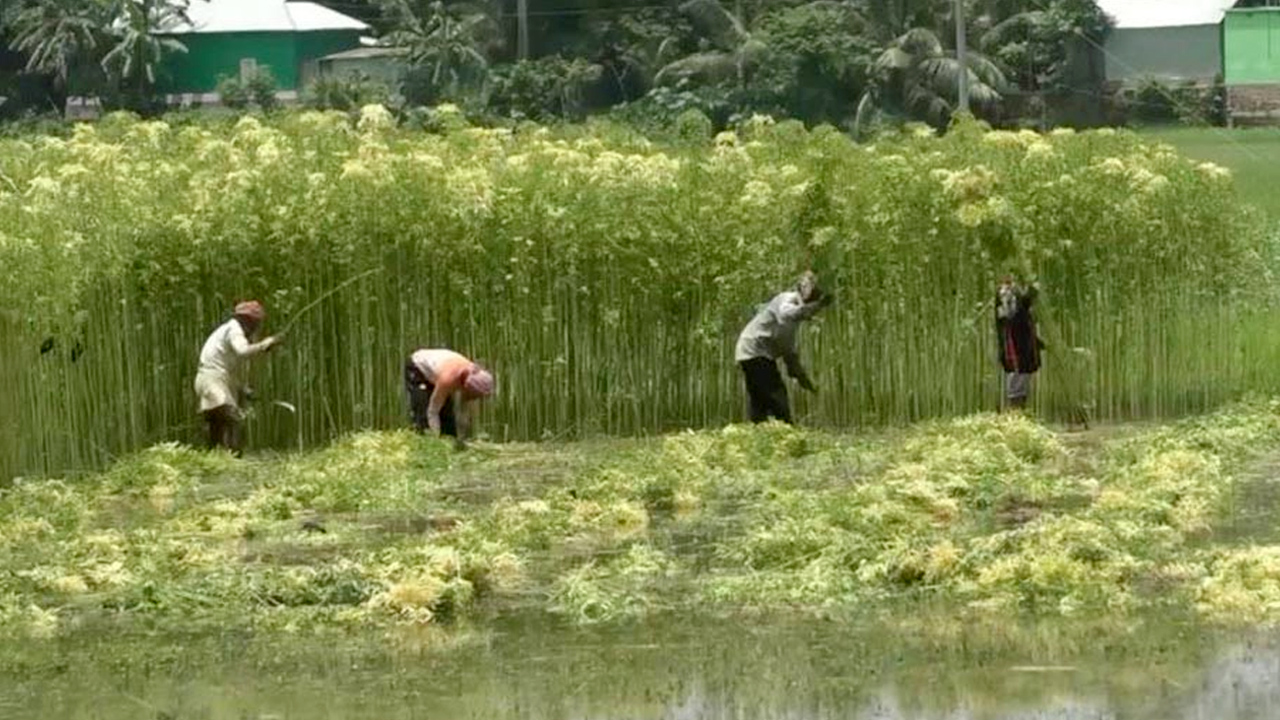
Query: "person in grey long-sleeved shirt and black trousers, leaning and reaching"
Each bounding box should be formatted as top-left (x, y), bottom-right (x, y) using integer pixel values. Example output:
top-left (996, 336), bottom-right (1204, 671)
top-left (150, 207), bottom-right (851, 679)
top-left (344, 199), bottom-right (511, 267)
top-left (733, 272), bottom-right (832, 423)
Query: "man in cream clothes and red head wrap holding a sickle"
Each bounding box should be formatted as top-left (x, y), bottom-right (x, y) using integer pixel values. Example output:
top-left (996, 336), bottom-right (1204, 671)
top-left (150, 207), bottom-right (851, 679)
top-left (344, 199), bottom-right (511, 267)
top-left (196, 300), bottom-right (279, 455)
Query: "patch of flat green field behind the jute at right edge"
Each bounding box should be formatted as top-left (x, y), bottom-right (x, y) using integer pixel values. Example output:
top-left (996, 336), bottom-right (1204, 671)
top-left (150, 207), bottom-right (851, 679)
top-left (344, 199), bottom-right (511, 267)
top-left (1142, 128), bottom-right (1280, 218)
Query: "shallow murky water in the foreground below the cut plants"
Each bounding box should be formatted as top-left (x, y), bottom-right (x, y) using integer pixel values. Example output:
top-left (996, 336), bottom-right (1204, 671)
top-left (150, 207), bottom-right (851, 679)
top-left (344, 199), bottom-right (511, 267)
top-left (0, 609), bottom-right (1280, 720)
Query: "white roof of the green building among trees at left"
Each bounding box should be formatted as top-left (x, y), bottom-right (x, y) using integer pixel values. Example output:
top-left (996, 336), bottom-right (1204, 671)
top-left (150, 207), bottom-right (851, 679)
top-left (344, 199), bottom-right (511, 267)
top-left (165, 0), bottom-right (369, 35)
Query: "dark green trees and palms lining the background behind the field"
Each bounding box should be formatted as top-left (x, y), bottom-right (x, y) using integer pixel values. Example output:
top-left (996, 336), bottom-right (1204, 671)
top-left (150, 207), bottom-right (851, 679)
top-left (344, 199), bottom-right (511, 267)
top-left (0, 0), bottom-right (1108, 131)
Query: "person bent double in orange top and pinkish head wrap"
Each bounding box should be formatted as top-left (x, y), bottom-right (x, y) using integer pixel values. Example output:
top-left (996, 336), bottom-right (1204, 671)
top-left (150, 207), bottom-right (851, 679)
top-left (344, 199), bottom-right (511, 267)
top-left (404, 348), bottom-right (493, 450)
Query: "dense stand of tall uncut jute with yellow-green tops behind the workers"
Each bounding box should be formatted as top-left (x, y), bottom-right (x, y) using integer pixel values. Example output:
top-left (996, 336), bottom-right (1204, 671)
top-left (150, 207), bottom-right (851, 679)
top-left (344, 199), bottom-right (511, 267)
top-left (0, 108), bottom-right (1275, 475)
